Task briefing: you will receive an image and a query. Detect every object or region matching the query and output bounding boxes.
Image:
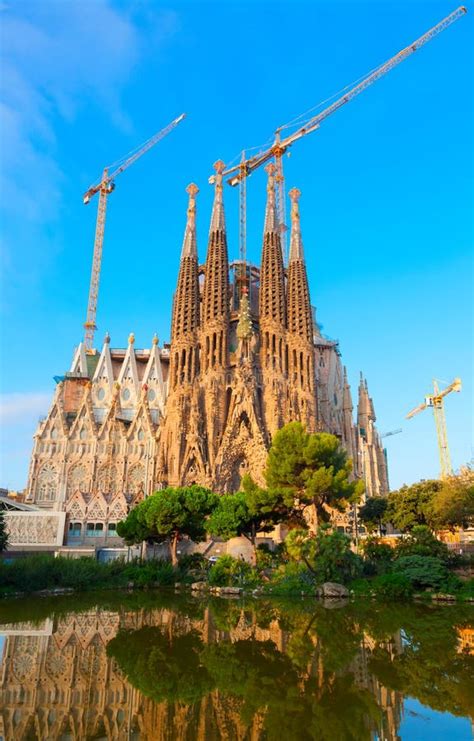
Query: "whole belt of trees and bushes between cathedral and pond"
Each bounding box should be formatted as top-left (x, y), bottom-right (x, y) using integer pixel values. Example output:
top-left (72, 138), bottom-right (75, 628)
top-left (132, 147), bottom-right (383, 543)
top-left (0, 422), bottom-right (474, 601)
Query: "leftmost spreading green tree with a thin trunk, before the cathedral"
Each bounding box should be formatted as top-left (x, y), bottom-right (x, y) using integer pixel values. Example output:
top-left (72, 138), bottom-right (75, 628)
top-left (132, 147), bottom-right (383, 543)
top-left (117, 486), bottom-right (219, 566)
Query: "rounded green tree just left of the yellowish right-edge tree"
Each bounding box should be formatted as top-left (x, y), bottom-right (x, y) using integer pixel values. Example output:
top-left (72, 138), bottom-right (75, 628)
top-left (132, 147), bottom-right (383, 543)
top-left (386, 480), bottom-right (442, 532)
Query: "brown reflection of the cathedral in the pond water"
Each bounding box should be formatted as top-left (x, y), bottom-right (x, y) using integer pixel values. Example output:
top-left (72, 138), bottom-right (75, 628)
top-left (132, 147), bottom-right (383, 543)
top-left (0, 608), bottom-right (402, 741)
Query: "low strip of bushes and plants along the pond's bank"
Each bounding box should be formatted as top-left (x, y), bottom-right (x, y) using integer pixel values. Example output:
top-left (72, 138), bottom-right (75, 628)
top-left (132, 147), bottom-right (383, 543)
top-left (0, 525), bottom-right (474, 603)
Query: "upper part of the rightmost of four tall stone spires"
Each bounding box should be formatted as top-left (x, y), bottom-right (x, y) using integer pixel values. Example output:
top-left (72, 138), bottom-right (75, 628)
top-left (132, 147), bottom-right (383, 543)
top-left (288, 188), bottom-right (313, 344)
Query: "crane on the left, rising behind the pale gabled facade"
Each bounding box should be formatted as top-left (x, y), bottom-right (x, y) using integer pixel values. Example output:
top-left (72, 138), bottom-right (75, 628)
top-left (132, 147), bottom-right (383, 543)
top-left (83, 113), bottom-right (186, 354)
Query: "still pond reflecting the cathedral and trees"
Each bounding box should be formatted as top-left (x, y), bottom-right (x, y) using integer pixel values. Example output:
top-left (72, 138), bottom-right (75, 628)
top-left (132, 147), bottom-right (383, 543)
top-left (0, 593), bottom-right (474, 741)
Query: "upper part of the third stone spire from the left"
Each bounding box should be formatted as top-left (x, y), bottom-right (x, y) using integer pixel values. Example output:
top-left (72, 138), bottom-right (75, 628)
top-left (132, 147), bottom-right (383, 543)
top-left (260, 163), bottom-right (286, 331)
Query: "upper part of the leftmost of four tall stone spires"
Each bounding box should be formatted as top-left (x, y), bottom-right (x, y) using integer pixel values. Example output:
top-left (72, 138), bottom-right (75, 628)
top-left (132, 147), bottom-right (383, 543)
top-left (170, 183), bottom-right (199, 390)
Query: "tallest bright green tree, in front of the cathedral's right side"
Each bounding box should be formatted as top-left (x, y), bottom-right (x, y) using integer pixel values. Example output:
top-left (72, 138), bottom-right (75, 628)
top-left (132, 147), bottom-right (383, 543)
top-left (265, 422), bottom-right (364, 522)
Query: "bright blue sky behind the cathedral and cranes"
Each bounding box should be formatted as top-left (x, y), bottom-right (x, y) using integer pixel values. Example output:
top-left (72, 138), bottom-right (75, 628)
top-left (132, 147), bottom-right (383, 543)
top-left (0, 0), bottom-right (474, 488)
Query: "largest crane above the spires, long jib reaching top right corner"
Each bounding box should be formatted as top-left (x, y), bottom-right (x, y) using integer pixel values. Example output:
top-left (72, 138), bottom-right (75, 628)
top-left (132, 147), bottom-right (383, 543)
top-left (215, 6), bottom-right (467, 262)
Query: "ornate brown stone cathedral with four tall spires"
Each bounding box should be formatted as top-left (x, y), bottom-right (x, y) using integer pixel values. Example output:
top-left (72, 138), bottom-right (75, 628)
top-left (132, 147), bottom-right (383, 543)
top-left (25, 161), bottom-right (388, 545)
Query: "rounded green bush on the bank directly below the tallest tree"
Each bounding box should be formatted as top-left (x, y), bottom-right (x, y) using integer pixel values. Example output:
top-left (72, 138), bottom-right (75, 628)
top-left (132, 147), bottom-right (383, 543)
top-left (285, 525), bottom-right (362, 584)
